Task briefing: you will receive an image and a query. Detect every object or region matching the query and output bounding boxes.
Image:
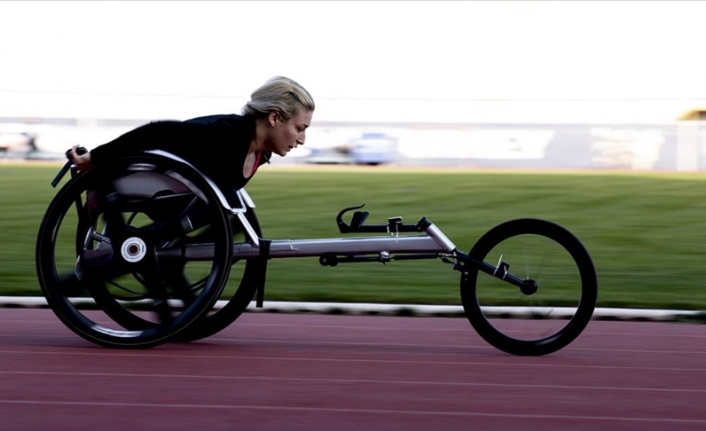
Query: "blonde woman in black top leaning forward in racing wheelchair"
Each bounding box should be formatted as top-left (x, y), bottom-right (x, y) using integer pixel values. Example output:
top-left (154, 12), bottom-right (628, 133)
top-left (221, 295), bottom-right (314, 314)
top-left (71, 76), bottom-right (314, 192)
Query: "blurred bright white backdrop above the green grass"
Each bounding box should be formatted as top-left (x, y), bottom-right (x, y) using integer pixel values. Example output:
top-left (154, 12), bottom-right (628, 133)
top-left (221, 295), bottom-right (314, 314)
top-left (0, 1), bottom-right (706, 171)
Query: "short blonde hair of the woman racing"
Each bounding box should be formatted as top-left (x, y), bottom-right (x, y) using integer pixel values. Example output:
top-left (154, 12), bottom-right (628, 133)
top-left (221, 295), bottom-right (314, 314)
top-left (242, 76), bottom-right (314, 121)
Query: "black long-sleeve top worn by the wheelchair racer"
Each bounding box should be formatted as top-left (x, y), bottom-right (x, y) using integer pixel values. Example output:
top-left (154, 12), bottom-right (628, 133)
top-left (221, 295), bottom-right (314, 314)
top-left (91, 114), bottom-right (271, 190)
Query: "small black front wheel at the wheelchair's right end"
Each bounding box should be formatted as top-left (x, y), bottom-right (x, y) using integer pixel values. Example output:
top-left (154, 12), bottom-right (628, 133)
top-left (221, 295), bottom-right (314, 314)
top-left (461, 219), bottom-right (598, 355)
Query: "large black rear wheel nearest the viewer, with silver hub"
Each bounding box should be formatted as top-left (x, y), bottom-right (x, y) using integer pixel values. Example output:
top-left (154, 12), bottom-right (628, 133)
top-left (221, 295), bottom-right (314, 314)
top-left (36, 154), bottom-right (232, 347)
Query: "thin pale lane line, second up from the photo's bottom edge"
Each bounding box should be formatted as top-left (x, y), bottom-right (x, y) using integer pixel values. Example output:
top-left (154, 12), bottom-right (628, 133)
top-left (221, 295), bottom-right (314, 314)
top-left (0, 371), bottom-right (706, 394)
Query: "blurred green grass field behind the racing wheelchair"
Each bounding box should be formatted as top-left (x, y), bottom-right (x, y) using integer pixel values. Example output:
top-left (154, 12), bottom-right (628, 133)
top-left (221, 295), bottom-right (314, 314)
top-left (0, 164), bottom-right (706, 309)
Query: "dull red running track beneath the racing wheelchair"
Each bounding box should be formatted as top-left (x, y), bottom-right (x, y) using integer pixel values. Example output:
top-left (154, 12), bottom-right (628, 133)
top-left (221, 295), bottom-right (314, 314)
top-left (0, 309), bottom-right (706, 431)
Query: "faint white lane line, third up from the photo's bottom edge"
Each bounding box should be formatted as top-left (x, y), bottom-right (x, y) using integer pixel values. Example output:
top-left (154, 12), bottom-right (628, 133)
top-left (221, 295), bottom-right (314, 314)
top-left (0, 350), bottom-right (706, 372)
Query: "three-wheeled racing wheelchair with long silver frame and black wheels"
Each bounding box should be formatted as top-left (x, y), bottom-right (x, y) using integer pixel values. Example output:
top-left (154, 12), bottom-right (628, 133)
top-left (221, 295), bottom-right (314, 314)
top-left (36, 150), bottom-right (598, 355)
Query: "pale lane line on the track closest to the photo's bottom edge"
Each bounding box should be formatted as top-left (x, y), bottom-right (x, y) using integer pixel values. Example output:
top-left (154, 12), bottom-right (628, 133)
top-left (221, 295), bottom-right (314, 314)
top-left (0, 399), bottom-right (706, 425)
